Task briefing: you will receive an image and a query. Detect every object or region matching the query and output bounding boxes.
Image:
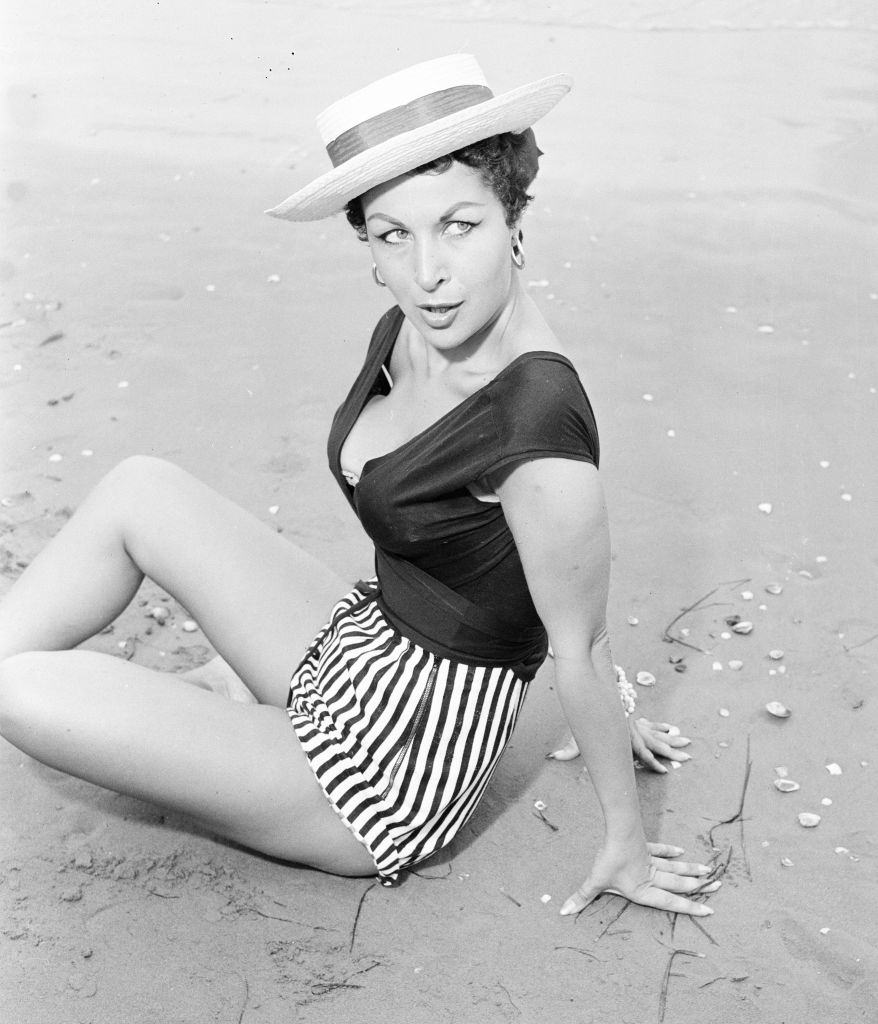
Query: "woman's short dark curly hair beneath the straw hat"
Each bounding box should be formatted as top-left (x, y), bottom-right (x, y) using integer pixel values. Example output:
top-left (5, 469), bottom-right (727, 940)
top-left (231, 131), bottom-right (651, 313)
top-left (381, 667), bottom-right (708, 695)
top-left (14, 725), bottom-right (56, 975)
top-left (344, 128), bottom-right (542, 242)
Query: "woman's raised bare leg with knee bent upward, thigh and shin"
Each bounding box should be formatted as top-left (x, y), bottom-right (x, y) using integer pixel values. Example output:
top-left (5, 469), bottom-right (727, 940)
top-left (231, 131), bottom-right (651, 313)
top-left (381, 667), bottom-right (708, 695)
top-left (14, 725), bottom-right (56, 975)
top-left (0, 457), bottom-right (346, 705)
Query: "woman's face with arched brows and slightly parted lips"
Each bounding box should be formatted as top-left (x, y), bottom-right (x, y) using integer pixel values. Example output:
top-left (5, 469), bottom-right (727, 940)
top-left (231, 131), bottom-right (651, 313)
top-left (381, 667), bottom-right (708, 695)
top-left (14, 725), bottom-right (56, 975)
top-left (363, 162), bottom-right (515, 351)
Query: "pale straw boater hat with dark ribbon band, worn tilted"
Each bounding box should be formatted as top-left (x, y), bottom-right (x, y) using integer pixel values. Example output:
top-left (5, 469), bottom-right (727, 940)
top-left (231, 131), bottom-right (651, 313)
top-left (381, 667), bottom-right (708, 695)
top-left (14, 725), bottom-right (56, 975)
top-left (265, 53), bottom-right (572, 220)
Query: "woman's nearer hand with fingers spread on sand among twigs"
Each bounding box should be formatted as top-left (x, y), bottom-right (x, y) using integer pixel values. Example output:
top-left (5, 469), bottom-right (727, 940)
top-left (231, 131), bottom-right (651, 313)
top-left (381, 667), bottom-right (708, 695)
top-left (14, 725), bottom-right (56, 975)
top-left (560, 842), bottom-right (722, 918)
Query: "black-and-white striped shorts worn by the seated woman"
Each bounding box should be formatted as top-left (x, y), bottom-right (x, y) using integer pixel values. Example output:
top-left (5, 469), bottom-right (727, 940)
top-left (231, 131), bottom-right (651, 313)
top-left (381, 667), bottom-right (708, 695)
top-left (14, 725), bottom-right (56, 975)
top-left (287, 581), bottom-right (528, 885)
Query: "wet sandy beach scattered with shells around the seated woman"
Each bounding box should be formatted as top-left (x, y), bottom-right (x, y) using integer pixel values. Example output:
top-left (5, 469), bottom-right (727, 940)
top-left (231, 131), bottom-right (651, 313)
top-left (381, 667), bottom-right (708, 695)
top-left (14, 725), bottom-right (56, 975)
top-left (0, 0), bottom-right (878, 1024)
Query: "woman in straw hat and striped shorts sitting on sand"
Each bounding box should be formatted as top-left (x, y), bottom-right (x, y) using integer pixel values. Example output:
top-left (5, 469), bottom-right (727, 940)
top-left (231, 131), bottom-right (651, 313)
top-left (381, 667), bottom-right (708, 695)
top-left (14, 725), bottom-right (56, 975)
top-left (0, 54), bottom-right (718, 915)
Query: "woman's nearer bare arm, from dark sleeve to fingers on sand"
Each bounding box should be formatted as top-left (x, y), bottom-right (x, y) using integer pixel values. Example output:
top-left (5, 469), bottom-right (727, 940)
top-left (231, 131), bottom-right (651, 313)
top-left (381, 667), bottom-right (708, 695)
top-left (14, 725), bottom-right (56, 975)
top-left (492, 458), bottom-right (717, 915)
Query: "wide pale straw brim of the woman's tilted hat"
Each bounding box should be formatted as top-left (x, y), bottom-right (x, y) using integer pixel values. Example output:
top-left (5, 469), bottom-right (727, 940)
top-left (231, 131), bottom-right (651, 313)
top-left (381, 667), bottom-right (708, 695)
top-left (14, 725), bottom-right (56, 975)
top-left (265, 75), bottom-right (573, 220)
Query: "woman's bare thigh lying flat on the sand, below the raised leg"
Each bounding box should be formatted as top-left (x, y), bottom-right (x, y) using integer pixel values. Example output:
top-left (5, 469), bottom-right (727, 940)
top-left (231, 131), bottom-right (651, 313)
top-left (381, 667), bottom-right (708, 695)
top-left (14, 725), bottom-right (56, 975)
top-left (0, 651), bottom-right (375, 874)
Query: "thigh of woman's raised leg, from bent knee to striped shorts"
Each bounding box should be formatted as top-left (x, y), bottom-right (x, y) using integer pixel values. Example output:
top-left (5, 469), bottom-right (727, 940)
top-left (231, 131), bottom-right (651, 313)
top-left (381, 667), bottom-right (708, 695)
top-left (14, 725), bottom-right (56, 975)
top-left (101, 458), bottom-right (350, 706)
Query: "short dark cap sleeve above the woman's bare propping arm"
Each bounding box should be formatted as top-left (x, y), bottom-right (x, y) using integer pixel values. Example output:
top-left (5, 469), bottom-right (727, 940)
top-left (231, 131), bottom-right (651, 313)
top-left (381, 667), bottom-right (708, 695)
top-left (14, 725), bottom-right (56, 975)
top-left (490, 352), bottom-right (600, 470)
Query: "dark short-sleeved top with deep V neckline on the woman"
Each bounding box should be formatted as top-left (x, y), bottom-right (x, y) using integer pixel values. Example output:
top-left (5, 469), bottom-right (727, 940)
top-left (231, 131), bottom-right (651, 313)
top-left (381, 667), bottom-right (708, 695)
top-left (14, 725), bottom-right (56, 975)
top-left (328, 307), bottom-right (599, 679)
